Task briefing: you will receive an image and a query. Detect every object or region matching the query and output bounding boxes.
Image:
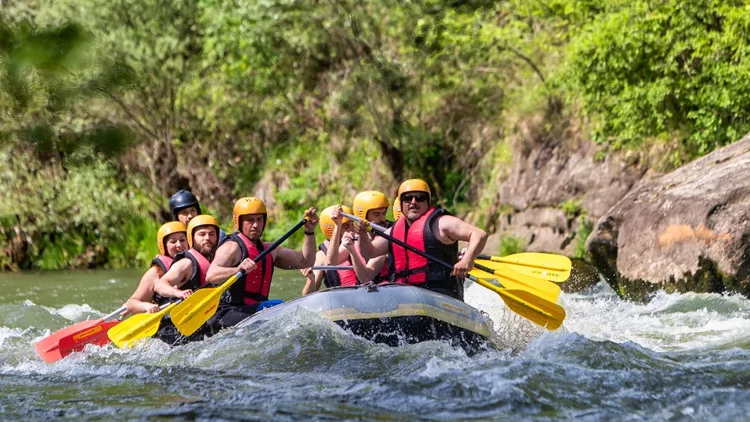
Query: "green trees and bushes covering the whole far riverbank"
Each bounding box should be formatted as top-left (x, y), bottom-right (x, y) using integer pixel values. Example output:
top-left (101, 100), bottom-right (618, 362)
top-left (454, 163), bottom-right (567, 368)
top-left (0, 0), bottom-right (750, 268)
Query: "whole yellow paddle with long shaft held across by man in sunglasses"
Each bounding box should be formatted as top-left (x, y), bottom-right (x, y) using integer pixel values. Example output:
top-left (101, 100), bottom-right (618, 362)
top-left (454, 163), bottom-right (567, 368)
top-left (341, 212), bottom-right (565, 330)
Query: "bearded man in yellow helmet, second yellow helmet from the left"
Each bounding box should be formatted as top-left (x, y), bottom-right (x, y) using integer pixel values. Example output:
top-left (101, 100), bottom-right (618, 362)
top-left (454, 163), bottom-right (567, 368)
top-left (154, 214), bottom-right (219, 345)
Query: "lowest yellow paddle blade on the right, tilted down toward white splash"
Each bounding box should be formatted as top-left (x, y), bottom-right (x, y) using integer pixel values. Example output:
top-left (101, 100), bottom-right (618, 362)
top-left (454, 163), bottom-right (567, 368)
top-left (474, 278), bottom-right (565, 330)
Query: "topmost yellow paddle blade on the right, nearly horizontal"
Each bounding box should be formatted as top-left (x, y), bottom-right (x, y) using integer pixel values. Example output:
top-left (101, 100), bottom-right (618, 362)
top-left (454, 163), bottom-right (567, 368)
top-left (477, 252), bottom-right (571, 283)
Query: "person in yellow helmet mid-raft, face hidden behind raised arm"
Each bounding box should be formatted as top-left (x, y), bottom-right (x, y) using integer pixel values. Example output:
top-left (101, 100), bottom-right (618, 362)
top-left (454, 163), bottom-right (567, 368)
top-left (302, 205), bottom-right (359, 296)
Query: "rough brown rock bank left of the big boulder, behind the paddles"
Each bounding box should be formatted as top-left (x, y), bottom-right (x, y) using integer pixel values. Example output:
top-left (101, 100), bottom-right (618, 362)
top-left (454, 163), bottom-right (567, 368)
top-left (485, 137), bottom-right (644, 256)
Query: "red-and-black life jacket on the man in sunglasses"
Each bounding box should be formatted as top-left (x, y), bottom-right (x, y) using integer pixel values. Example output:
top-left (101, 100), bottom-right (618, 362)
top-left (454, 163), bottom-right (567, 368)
top-left (389, 207), bottom-right (463, 299)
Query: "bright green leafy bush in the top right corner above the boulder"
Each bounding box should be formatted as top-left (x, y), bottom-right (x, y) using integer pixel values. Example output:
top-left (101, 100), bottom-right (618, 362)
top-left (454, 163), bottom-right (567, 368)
top-left (565, 0), bottom-right (750, 158)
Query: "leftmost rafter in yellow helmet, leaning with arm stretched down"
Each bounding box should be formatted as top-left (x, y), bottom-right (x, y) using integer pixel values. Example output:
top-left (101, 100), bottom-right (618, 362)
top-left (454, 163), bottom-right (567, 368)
top-left (125, 221), bottom-right (188, 314)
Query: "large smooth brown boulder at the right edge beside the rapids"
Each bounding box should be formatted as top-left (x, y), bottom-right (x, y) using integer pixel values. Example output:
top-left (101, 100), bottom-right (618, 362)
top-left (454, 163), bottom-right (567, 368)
top-left (586, 136), bottom-right (750, 299)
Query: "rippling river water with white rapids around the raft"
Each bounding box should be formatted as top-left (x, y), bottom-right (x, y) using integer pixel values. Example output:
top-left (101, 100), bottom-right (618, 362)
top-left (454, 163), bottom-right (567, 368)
top-left (0, 271), bottom-right (750, 421)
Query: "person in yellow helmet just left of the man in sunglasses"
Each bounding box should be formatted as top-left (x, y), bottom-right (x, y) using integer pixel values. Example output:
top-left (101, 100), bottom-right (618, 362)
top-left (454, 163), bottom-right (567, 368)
top-left (327, 191), bottom-right (394, 283)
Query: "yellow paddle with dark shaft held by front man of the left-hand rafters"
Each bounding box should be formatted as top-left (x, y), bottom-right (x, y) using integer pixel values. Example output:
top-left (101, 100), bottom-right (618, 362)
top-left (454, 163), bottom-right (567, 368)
top-left (170, 218), bottom-right (307, 336)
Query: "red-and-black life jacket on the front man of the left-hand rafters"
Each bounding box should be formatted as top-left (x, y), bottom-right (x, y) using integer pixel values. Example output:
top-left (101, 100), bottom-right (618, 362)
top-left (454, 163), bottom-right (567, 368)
top-left (225, 231), bottom-right (280, 306)
